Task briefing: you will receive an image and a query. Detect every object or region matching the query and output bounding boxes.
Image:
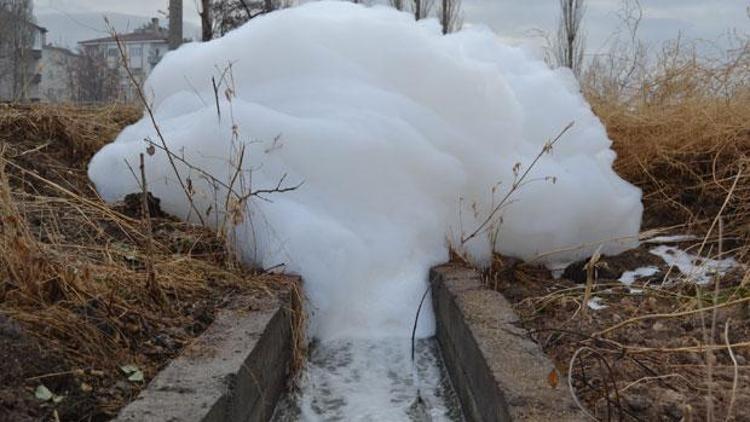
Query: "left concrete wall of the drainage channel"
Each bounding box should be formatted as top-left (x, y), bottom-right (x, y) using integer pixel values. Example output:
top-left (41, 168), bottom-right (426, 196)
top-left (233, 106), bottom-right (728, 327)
top-left (115, 293), bottom-right (293, 422)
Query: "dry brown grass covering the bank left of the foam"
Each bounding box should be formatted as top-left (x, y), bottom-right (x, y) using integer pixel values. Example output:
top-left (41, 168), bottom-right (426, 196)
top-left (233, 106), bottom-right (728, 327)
top-left (0, 106), bottom-right (296, 420)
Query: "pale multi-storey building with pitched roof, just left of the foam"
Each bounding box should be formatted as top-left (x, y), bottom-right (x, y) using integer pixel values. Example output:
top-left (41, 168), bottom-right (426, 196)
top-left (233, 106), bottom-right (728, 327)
top-left (79, 18), bottom-right (169, 101)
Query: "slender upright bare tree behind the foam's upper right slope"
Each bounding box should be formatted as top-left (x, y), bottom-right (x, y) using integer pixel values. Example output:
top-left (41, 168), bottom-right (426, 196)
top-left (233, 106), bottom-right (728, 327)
top-left (555, 0), bottom-right (586, 76)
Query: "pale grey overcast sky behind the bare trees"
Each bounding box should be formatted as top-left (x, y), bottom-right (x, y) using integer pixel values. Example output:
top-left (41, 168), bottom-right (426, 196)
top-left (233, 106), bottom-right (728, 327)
top-left (34, 0), bottom-right (750, 52)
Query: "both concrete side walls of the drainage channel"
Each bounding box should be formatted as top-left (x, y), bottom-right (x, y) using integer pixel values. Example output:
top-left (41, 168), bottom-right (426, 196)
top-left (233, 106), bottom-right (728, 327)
top-left (116, 265), bottom-right (585, 422)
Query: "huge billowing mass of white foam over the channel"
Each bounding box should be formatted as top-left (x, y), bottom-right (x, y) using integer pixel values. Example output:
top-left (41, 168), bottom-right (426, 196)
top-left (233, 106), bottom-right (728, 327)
top-left (89, 2), bottom-right (642, 338)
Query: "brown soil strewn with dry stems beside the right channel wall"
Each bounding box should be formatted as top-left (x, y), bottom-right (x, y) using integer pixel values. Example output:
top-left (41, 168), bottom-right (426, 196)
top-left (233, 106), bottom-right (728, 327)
top-left (485, 244), bottom-right (750, 421)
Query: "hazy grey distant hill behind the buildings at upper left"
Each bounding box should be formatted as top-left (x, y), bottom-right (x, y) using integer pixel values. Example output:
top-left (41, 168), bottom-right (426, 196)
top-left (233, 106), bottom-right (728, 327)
top-left (37, 13), bottom-right (200, 50)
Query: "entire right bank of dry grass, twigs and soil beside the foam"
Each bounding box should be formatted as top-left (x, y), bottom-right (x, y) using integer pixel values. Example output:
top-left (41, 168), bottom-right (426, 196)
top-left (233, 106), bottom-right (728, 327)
top-left (487, 40), bottom-right (750, 421)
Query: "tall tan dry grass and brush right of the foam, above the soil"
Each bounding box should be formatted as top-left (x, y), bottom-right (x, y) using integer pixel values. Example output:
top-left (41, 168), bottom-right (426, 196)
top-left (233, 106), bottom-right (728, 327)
top-left (584, 40), bottom-right (750, 258)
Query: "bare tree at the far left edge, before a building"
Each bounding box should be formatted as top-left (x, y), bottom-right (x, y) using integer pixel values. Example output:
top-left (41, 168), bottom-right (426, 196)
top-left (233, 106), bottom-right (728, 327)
top-left (0, 0), bottom-right (36, 101)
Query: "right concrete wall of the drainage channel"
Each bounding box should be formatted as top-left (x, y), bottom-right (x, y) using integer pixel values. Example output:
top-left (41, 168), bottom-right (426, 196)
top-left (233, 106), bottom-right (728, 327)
top-left (430, 264), bottom-right (586, 422)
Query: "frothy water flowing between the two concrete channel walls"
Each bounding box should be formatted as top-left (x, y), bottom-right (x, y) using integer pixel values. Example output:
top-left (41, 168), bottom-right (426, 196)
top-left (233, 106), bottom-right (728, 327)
top-left (273, 338), bottom-right (464, 422)
